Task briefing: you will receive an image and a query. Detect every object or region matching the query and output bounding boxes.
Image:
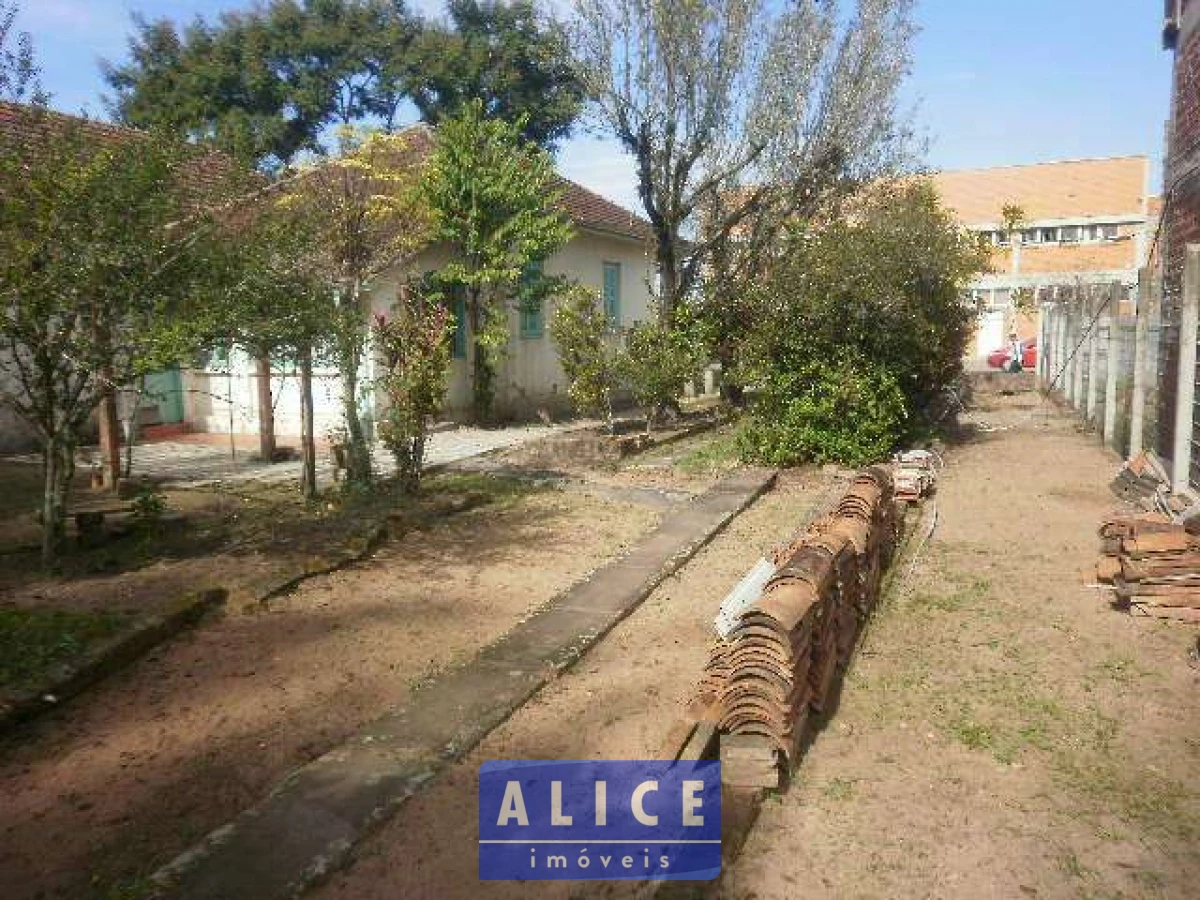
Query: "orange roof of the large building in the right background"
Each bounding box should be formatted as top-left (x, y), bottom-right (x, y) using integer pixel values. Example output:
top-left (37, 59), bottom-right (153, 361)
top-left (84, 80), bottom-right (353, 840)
top-left (932, 156), bottom-right (1150, 226)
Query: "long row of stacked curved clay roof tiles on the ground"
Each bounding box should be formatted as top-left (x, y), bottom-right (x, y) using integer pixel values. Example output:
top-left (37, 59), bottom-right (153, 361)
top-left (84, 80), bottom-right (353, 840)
top-left (701, 469), bottom-right (895, 786)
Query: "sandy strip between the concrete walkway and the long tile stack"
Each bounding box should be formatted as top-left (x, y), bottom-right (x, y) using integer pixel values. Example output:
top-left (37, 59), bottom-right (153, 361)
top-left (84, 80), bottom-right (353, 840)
top-left (312, 472), bottom-right (830, 900)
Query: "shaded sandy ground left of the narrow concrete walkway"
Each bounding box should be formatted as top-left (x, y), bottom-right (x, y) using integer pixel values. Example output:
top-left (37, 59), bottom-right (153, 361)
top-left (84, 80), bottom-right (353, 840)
top-left (0, 491), bottom-right (659, 900)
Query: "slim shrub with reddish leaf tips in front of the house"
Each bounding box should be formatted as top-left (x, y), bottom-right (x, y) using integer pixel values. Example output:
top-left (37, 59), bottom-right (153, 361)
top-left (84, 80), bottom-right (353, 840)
top-left (373, 286), bottom-right (454, 493)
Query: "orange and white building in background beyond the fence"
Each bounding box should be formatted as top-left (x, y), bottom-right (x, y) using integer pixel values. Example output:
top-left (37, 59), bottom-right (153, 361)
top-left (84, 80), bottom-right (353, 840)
top-left (934, 156), bottom-right (1158, 360)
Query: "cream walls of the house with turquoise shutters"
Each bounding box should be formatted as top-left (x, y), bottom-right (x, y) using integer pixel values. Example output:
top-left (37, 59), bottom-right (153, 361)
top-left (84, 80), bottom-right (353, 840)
top-left (177, 229), bottom-right (654, 436)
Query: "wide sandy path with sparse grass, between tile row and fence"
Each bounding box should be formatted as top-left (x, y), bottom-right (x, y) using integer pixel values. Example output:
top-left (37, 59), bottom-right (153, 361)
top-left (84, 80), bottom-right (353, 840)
top-left (724, 395), bottom-right (1200, 900)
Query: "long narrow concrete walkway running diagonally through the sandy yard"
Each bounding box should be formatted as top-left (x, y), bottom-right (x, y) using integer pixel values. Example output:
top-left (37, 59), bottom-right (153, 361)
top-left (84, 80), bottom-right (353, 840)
top-left (155, 469), bottom-right (775, 900)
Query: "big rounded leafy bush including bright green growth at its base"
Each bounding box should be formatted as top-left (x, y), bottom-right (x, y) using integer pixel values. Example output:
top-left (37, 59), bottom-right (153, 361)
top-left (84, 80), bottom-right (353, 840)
top-left (736, 180), bottom-right (988, 462)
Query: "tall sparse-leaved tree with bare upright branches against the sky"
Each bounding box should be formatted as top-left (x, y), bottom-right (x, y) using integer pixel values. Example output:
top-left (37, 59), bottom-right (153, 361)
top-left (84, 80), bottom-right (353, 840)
top-left (574, 0), bottom-right (913, 323)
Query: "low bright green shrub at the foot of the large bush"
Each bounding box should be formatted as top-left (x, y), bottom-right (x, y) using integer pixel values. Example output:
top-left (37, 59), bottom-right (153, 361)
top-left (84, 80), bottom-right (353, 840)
top-left (738, 354), bottom-right (905, 466)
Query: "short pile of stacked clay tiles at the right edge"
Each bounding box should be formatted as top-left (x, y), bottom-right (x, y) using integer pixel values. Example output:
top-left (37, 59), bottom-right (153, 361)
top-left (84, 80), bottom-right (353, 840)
top-left (1096, 512), bottom-right (1200, 623)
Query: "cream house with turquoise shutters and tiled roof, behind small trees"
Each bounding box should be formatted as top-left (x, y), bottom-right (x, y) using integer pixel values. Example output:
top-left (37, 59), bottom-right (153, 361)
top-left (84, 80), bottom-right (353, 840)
top-left (185, 126), bottom-right (654, 434)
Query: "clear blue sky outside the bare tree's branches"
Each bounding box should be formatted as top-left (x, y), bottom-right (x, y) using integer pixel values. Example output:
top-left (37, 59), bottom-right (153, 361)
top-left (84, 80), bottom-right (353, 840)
top-left (11, 0), bottom-right (1170, 209)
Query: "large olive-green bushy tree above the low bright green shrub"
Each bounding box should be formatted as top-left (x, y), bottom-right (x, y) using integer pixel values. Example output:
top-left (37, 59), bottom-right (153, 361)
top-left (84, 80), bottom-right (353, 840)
top-left (725, 182), bottom-right (988, 434)
